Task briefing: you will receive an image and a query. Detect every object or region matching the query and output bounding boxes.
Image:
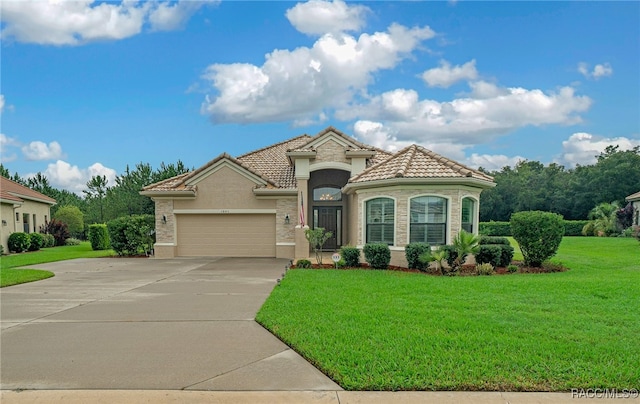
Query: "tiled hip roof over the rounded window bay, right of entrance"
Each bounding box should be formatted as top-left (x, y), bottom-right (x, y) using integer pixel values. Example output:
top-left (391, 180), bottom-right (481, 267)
top-left (349, 144), bottom-right (493, 183)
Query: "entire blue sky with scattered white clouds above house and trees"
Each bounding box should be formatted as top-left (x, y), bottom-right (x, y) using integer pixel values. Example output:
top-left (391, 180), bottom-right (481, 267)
top-left (0, 0), bottom-right (640, 192)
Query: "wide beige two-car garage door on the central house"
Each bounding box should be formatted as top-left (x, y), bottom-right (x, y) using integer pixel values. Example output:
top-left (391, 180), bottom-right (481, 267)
top-left (176, 214), bottom-right (276, 257)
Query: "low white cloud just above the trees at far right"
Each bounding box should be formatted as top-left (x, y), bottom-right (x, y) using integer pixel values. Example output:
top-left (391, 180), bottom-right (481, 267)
top-left (558, 132), bottom-right (640, 167)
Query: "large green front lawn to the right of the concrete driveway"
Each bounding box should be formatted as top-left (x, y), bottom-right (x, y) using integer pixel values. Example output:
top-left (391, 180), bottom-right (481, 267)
top-left (256, 237), bottom-right (640, 391)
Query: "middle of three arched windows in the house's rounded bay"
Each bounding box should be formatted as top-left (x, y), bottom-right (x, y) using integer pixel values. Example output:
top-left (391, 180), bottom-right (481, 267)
top-left (409, 196), bottom-right (447, 245)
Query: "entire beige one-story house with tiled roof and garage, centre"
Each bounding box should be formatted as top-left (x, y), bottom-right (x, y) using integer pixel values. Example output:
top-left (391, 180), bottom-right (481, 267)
top-left (141, 127), bottom-right (495, 265)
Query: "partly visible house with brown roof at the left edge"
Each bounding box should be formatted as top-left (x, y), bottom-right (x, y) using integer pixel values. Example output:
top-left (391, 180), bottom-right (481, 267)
top-left (0, 176), bottom-right (56, 253)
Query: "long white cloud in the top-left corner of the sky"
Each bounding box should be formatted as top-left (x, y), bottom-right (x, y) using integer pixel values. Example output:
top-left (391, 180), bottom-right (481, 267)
top-left (0, 0), bottom-right (216, 45)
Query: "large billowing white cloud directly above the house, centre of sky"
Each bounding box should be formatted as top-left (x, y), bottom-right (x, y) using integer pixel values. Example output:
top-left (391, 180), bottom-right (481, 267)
top-left (202, 24), bottom-right (435, 123)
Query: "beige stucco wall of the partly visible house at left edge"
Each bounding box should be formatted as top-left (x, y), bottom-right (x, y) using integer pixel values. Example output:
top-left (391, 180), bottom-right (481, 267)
top-left (0, 200), bottom-right (51, 253)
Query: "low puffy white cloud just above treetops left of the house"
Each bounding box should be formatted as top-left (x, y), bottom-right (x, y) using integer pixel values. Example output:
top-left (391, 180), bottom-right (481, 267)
top-left (37, 160), bottom-right (116, 194)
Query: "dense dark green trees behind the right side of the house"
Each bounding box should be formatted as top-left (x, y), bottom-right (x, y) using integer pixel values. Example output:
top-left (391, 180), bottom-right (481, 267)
top-left (480, 146), bottom-right (640, 222)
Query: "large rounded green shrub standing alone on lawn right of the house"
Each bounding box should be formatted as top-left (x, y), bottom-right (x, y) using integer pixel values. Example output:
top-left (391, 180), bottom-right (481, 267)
top-left (510, 210), bottom-right (564, 267)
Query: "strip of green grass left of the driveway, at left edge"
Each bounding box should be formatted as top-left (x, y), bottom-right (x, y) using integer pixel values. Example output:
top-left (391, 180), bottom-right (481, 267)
top-left (0, 242), bottom-right (114, 287)
